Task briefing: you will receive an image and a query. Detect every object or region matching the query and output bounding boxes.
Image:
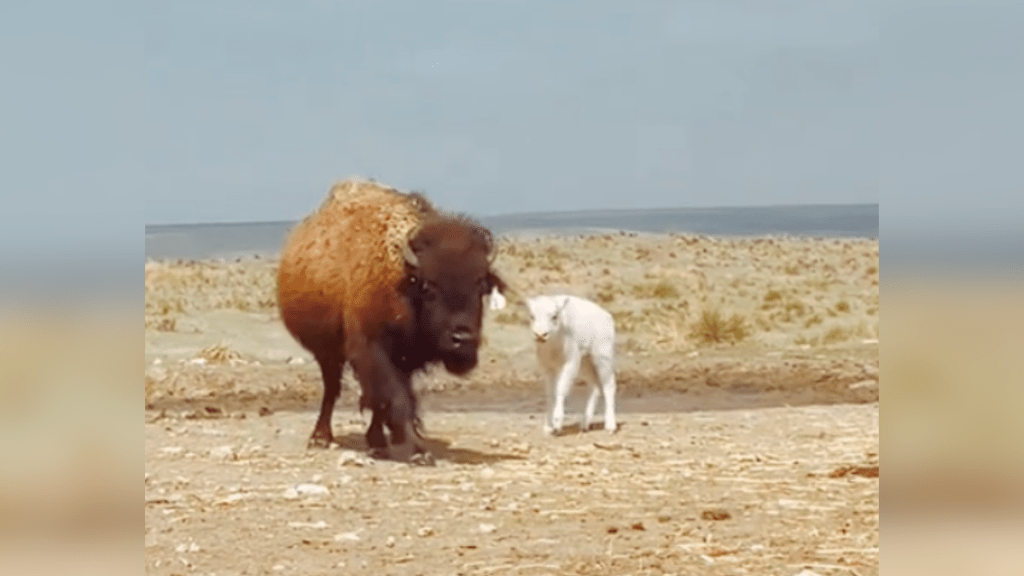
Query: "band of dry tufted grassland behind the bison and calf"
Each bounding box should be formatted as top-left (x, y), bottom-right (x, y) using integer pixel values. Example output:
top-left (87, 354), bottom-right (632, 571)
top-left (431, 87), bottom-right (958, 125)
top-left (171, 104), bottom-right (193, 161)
top-left (145, 234), bottom-right (879, 351)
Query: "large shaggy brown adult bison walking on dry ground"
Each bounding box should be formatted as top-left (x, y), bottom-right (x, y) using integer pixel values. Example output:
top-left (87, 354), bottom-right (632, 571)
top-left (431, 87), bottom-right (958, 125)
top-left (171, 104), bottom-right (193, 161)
top-left (278, 178), bottom-right (506, 457)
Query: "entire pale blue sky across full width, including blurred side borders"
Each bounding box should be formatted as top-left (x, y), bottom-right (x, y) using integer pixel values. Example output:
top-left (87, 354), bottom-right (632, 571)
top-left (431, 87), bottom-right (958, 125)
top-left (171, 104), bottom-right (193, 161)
top-left (0, 0), bottom-right (1024, 262)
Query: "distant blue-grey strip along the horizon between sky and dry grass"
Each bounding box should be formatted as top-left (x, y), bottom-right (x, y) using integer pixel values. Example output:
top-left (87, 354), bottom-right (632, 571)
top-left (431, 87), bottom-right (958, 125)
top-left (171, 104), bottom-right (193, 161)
top-left (145, 204), bottom-right (879, 259)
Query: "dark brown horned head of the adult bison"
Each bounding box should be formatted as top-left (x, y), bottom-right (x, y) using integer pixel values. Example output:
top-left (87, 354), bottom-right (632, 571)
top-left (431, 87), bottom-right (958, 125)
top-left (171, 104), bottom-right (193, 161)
top-left (404, 218), bottom-right (505, 375)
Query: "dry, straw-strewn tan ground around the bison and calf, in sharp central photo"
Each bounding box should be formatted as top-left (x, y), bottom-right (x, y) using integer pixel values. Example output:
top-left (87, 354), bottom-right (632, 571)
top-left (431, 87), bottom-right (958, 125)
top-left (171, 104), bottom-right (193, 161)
top-left (145, 230), bottom-right (879, 576)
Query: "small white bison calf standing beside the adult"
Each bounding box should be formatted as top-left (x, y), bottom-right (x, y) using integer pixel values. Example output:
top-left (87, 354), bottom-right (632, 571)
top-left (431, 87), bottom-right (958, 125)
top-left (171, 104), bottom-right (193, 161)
top-left (526, 295), bottom-right (616, 435)
